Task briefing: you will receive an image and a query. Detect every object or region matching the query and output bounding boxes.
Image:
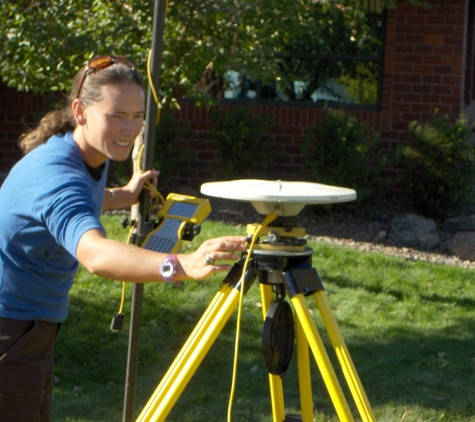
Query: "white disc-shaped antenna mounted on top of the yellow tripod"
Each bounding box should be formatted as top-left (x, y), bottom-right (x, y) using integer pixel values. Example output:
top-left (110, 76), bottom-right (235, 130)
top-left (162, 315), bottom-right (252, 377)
top-left (201, 179), bottom-right (356, 217)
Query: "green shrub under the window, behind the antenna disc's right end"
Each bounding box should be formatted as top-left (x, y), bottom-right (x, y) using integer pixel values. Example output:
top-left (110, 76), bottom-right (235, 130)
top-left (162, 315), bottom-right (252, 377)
top-left (302, 109), bottom-right (386, 201)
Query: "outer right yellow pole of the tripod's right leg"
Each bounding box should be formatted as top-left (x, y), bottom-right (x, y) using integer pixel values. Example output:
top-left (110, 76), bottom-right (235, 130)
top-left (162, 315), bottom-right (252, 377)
top-left (313, 291), bottom-right (376, 422)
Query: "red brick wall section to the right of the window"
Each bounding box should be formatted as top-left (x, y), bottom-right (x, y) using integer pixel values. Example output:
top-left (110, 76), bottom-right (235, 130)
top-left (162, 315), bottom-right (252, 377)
top-left (381, 0), bottom-right (468, 148)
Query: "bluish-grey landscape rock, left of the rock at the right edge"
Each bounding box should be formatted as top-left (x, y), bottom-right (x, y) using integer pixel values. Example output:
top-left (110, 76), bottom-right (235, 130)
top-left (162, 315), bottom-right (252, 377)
top-left (389, 214), bottom-right (440, 251)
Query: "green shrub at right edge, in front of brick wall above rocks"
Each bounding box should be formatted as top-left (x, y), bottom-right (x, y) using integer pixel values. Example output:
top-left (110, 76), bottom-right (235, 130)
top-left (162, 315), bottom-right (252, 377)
top-left (397, 112), bottom-right (475, 218)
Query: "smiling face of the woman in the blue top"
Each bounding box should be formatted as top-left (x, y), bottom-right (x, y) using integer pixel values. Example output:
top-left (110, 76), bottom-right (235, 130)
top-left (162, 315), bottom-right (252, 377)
top-left (74, 83), bottom-right (145, 167)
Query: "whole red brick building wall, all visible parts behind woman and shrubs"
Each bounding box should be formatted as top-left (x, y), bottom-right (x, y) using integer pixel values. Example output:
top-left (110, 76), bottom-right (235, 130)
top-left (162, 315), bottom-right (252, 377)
top-left (0, 0), bottom-right (475, 186)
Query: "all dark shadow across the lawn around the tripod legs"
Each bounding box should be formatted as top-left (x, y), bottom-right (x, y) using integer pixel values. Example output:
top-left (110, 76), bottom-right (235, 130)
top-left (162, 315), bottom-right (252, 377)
top-left (54, 277), bottom-right (475, 422)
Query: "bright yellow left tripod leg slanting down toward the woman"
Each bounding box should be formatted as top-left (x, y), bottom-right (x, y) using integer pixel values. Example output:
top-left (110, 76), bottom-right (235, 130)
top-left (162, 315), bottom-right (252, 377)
top-left (137, 285), bottom-right (239, 422)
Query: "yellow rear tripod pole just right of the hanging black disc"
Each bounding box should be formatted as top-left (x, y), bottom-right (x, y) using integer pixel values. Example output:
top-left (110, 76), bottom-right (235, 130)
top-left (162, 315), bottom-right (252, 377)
top-left (295, 308), bottom-right (313, 422)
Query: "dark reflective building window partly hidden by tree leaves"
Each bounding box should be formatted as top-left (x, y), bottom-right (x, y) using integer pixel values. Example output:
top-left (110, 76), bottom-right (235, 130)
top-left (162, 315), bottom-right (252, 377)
top-left (219, 0), bottom-right (386, 109)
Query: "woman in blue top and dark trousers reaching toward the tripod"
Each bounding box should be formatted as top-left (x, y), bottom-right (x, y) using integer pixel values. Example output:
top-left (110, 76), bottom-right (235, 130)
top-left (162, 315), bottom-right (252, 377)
top-left (0, 56), bottom-right (246, 422)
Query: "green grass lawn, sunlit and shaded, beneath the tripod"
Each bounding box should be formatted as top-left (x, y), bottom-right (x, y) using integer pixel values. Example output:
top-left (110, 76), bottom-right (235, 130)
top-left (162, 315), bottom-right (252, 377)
top-left (53, 216), bottom-right (475, 422)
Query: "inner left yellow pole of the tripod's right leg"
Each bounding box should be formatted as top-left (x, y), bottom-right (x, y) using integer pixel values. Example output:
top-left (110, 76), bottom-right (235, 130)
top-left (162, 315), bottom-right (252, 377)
top-left (291, 294), bottom-right (354, 422)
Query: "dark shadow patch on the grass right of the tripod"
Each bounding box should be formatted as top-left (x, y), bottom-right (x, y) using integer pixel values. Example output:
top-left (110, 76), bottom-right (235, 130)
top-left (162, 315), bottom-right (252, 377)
top-left (348, 319), bottom-right (475, 420)
